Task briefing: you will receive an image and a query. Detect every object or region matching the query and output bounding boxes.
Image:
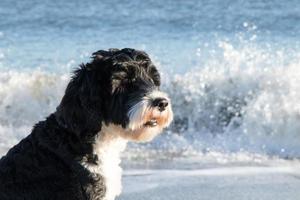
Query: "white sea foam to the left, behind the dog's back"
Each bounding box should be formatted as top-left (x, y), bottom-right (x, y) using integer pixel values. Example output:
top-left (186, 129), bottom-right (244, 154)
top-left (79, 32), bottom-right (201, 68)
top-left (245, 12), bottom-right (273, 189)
top-left (0, 70), bottom-right (68, 152)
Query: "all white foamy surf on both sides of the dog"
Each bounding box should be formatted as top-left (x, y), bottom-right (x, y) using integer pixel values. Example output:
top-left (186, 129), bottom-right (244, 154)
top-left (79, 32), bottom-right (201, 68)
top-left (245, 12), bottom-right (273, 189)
top-left (0, 42), bottom-right (300, 162)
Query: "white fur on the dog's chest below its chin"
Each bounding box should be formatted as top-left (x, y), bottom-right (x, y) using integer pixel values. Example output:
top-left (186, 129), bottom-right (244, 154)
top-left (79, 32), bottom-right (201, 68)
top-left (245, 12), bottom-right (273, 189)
top-left (85, 126), bottom-right (127, 200)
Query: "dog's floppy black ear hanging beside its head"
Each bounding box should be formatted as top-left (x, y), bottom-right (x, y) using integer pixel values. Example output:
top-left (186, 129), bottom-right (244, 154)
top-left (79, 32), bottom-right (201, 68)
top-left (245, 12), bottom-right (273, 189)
top-left (56, 65), bottom-right (102, 136)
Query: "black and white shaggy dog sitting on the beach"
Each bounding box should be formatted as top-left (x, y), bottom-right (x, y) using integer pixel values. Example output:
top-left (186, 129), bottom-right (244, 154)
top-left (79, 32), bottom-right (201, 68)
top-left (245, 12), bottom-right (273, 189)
top-left (0, 48), bottom-right (173, 200)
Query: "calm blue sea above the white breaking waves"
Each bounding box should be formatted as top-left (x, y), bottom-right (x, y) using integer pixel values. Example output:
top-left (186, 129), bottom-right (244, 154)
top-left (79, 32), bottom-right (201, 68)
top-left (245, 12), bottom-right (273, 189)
top-left (0, 0), bottom-right (300, 72)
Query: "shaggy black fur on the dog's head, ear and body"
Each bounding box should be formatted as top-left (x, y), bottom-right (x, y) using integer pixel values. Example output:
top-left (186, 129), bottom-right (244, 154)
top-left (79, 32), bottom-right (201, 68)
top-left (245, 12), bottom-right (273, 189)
top-left (0, 49), bottom-right (160, 200)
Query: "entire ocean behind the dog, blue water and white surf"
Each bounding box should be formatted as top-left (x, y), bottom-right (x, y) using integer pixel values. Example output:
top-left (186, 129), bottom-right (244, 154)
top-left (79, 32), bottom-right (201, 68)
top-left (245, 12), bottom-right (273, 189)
top-left (0, 0), bottom-right (300, 168)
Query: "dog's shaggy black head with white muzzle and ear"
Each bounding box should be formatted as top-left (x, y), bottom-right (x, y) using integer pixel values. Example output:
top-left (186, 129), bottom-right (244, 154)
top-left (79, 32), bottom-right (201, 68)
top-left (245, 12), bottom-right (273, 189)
top-left (57, 49), bottom-right (173, 141)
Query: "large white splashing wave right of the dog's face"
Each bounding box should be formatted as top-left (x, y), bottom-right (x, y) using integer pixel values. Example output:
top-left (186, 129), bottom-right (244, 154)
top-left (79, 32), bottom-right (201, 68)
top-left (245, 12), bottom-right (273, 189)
top-left (156, 42), bottom-right (300, 157)
